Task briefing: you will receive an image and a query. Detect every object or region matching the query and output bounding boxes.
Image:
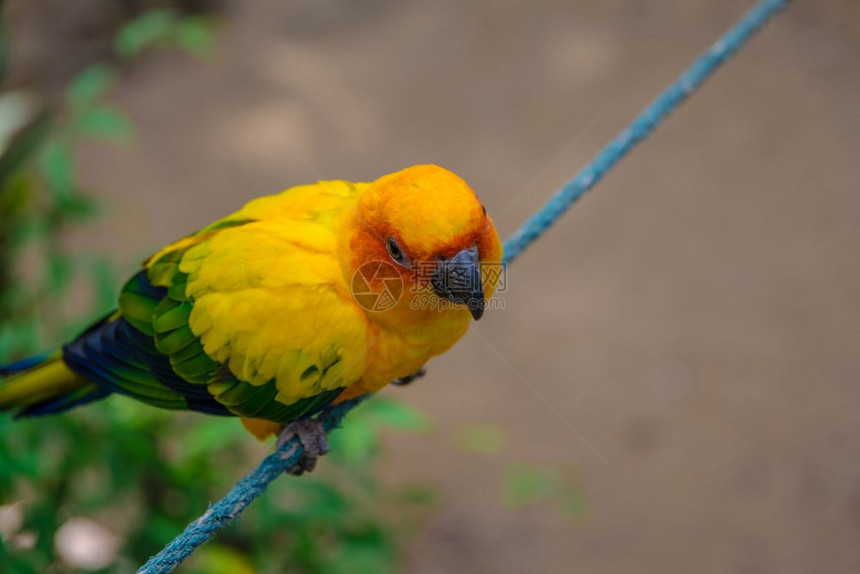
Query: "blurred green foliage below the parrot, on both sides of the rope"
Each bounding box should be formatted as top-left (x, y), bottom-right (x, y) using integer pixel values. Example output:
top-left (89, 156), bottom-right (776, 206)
top-left (0, 397), bottom-right (434, 574)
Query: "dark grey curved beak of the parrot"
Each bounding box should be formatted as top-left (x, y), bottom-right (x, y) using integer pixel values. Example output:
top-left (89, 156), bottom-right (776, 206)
top-left (430, 247), bottom-right (487, 321)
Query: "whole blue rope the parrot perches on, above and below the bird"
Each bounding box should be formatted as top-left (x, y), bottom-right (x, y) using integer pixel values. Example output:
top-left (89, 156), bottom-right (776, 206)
top-left (137, 0), bottom-right (791, 574)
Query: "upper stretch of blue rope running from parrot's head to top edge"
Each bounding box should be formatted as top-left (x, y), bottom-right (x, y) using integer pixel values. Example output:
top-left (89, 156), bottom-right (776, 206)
top-left (505, 0), bottom-right (791, 263)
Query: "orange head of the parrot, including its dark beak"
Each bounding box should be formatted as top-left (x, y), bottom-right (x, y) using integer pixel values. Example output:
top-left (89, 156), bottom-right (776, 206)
top-left (350, 165), bottom-right (502, 323)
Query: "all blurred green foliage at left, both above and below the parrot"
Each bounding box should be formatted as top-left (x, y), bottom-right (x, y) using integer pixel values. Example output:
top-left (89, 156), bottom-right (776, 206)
top-left (0, 10), bottom-right (434, 574)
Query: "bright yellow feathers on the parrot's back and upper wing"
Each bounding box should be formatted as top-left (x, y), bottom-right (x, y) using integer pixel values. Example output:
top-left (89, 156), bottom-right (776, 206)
top-left (147, 181), bottom-right (367, 405)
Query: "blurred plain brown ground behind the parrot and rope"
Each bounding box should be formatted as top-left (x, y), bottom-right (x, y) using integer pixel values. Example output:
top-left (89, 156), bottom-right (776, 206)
top-left (11, 0), bottom-right (860, 574)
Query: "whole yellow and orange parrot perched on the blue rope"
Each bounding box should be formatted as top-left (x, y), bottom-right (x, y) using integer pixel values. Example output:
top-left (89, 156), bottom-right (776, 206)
top-left (0, 165), bottom-right (502, 474)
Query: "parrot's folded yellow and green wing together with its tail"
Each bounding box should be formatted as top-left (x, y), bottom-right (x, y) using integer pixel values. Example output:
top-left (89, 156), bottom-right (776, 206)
top-left (0, 194), bottom-right (366, 422)
